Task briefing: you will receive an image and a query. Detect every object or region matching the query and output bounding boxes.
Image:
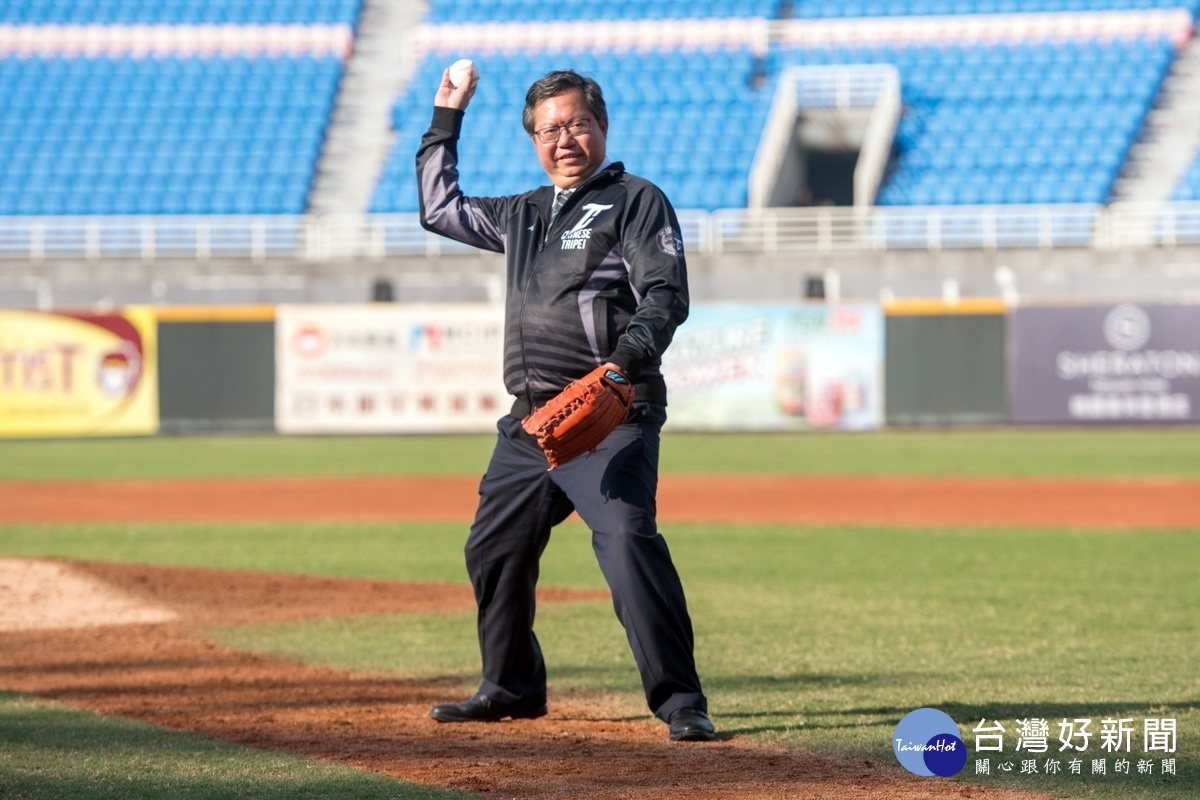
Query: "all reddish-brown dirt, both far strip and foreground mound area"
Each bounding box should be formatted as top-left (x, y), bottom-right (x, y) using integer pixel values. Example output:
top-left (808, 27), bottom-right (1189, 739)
top-left (0, 477), bottom-right (1200, 800)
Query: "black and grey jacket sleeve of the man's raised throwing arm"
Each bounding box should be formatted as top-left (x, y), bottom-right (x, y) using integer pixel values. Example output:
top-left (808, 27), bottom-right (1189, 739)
top-left (416, 107), bottom-right (508, 253)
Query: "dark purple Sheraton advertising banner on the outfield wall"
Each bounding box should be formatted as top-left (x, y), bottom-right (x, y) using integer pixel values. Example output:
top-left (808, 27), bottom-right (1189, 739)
top-left (1008, 303), bottom-right (1200, 423)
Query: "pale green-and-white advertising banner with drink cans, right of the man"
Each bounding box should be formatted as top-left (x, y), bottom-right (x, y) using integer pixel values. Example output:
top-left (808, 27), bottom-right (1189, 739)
top-left (662, 302), bottom-right (883, 431)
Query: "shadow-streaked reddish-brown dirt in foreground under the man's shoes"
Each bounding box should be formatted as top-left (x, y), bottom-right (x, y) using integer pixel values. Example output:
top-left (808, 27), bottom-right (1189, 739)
top-left (0, 560), bottom-right (1051, 800)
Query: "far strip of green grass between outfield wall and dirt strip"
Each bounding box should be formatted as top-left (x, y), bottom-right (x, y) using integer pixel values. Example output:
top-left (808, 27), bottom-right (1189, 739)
top-left (7, 427), bottom-right (1200, 480)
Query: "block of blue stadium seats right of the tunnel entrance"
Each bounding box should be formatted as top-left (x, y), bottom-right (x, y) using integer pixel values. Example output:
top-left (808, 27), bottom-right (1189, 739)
top-left (806, 40), bottom-right (1169, 205)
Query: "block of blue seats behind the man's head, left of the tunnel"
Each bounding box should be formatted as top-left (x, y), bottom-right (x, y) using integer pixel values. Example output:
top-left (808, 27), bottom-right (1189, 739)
top-left (371, 45), bottom-right (768, 211)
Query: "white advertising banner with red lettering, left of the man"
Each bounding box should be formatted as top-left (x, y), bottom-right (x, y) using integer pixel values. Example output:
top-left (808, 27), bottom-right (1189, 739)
top-left (275, 305), bottom-right (512, 433)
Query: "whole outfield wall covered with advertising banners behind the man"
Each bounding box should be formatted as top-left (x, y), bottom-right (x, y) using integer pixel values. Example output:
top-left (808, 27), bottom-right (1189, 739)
top-left (0, 299), bottom-right (1200, 438)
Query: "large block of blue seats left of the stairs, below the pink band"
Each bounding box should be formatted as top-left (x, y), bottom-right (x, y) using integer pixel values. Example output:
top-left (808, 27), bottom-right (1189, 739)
top-left (0, 56), bottom-right (341, 213)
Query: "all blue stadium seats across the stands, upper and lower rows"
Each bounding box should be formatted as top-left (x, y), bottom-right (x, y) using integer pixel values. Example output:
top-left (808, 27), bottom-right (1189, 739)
top-left (0, 0), bottom-right (1200, 213)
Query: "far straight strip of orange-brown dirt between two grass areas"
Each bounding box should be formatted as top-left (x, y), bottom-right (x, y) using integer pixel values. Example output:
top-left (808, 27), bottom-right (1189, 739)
top-left (0, 476), bottom-right (1200, 529)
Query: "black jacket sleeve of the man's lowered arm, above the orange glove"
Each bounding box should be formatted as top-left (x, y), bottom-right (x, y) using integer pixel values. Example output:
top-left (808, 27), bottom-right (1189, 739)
top-left (610, 184), bottom-right (689, 377)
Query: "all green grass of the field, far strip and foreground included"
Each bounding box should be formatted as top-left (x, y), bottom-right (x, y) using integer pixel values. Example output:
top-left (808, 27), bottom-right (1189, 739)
top-left (0, 428), bottom-right (1200, 800)
